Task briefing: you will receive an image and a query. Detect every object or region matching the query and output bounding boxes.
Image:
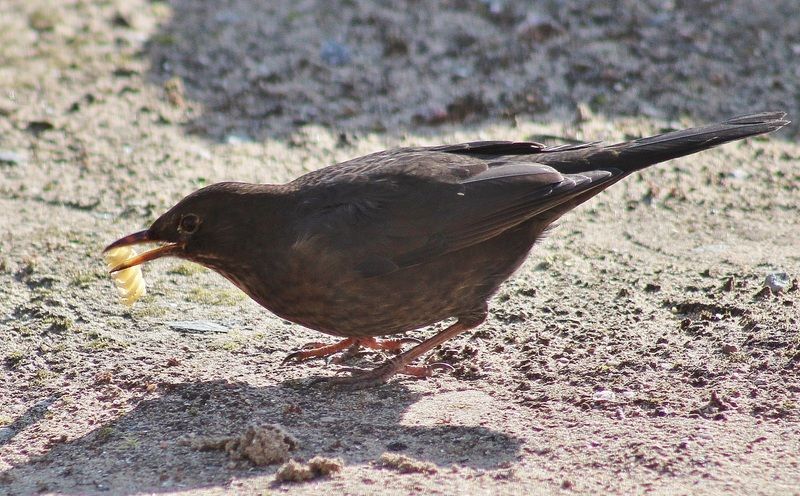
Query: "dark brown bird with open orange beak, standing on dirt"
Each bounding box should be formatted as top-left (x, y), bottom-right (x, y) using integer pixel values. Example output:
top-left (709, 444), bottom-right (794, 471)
top-left (107, 112), bottom-right (789, 387)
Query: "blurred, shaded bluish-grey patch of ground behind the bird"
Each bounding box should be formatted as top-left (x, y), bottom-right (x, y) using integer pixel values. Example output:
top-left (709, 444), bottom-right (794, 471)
top-left (146, 0), bottom-right (800, 138)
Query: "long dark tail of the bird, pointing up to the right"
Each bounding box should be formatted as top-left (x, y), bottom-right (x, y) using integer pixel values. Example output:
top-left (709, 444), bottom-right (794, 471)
top-left (537, 112), bottom-right (790, 173)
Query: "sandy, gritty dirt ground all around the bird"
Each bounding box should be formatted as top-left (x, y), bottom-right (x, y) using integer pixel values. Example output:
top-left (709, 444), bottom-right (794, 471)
top-left (0, 0), bottom-right (800, 495)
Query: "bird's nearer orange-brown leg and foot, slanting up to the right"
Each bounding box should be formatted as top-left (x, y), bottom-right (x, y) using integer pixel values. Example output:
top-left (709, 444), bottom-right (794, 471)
top-left (316, 305), bottom-right (487, 389)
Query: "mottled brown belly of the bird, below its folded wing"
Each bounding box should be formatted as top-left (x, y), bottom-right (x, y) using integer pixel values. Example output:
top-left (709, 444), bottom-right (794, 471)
top-left (251, 224), bottom-right (538, 336)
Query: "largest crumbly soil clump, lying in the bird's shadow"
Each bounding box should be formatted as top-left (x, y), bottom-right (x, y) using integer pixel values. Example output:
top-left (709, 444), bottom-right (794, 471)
top-left (182, 424), bottom-right (299, 466)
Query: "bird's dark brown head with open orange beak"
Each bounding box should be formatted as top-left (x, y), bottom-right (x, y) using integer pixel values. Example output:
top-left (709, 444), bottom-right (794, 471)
top-left (104, 182), bottom-right (266, 272)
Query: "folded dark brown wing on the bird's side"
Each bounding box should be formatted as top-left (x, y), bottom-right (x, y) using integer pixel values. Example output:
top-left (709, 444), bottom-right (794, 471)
top-left (298, 147), bottom-right (614, 277)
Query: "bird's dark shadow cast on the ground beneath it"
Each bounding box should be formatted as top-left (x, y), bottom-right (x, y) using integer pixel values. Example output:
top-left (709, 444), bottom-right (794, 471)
top-left (0, 380), bottom-right (521, 494)
